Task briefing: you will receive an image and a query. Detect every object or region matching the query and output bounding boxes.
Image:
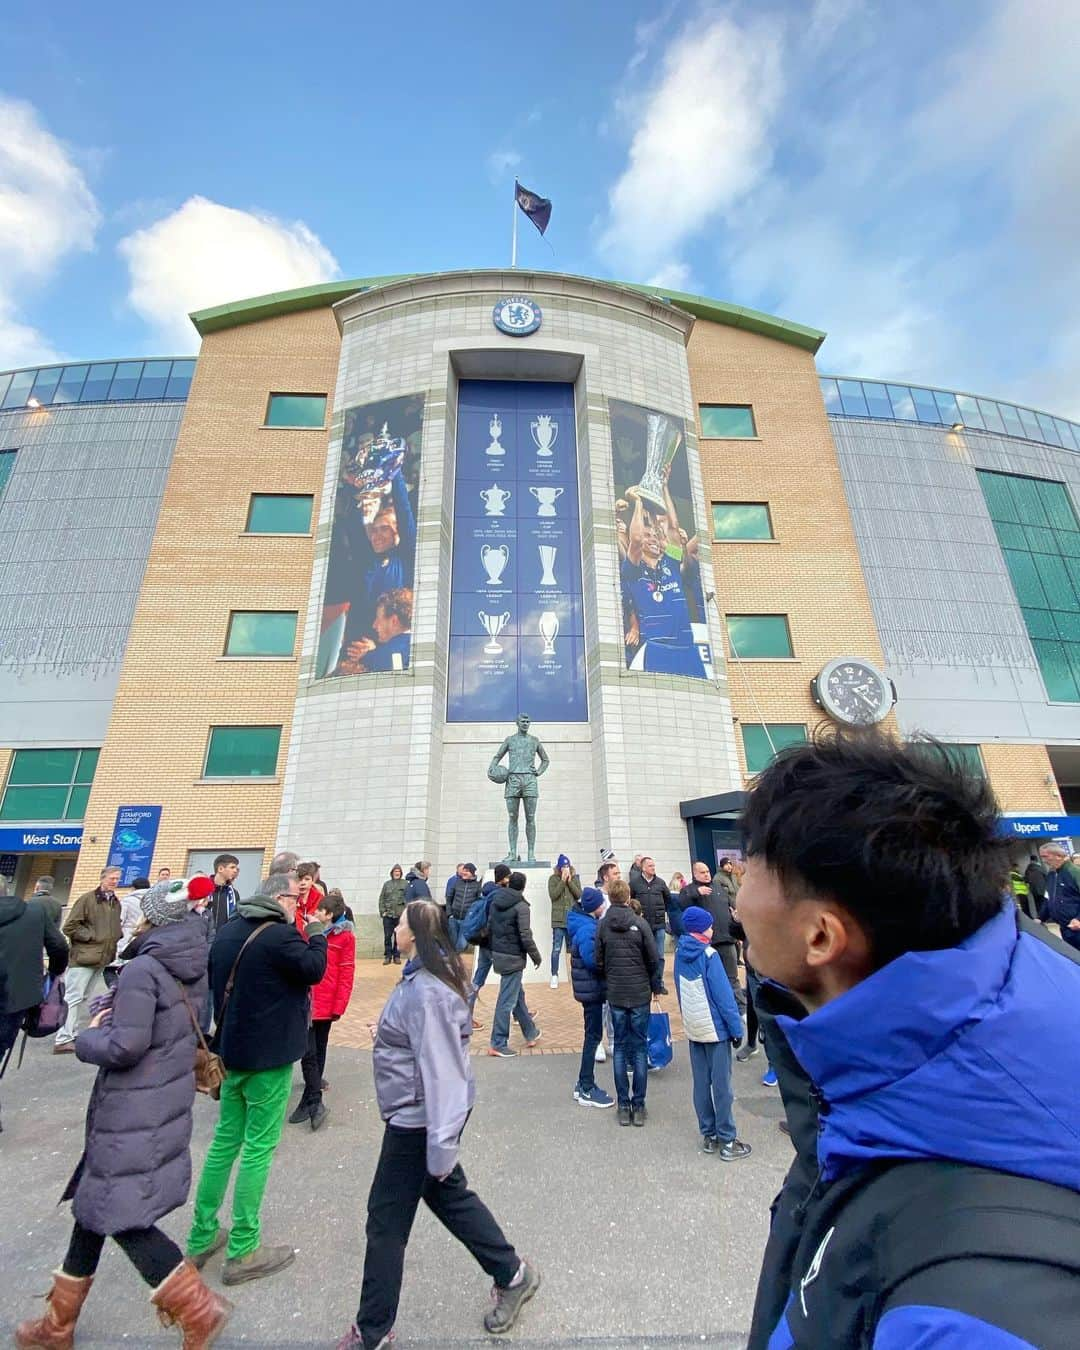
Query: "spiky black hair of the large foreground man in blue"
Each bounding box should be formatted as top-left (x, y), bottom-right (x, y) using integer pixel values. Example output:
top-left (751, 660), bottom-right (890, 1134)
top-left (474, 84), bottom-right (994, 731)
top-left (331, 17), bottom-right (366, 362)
top-left (741, 730), bottom-right (1015, 969)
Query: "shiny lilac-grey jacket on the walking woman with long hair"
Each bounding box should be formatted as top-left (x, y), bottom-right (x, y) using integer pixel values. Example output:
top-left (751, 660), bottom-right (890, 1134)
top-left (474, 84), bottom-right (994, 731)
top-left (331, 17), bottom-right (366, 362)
top-left (373, 959), bottom-right (477, 1177)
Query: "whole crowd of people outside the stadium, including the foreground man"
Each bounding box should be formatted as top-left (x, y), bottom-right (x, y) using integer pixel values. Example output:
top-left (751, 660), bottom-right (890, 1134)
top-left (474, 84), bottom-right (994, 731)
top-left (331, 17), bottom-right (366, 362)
top-left (0, 733), bottom-right (1080, 1350)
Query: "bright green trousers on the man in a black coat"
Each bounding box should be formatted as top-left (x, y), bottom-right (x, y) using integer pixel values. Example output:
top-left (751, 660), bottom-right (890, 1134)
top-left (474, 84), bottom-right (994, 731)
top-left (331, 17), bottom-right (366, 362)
top-left (188, 1064), bottom-right (294, 1260)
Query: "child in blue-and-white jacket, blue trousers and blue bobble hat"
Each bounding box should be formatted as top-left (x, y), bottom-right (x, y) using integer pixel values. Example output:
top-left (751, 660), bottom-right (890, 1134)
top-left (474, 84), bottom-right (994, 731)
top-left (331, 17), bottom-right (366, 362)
top-left (675, 905), bottom-right (751, 1162)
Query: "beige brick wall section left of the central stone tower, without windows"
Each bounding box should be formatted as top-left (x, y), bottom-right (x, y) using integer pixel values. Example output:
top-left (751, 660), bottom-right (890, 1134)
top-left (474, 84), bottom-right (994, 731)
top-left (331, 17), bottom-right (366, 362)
top-left (74, 309), bottom-right (339, 892)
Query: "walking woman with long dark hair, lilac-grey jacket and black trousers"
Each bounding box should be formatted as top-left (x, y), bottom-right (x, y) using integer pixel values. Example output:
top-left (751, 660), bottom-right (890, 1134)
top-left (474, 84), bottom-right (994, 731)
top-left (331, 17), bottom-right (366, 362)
top-left (338, 900), bottom-right (540, 1350)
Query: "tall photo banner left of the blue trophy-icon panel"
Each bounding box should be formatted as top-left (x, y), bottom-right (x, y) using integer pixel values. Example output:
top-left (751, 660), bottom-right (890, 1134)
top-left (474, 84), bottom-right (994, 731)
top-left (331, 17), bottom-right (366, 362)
top-left (315, 394), bottom-right (424, 679)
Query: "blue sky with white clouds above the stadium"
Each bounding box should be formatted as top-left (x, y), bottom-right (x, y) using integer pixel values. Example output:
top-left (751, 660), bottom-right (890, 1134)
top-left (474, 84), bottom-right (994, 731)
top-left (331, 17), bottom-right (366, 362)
top-left (0, 0), bottom-right (1080, 416)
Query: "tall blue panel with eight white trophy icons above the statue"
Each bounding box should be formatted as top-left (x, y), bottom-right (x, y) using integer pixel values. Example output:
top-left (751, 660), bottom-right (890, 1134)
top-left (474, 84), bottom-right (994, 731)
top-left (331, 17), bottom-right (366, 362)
top-left (447, 379), bottom-right (589, 722)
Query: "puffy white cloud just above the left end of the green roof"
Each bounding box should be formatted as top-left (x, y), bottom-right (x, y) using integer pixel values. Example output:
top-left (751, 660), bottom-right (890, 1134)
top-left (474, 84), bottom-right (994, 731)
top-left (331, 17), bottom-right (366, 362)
top-left (117, 197), bottom-right (340, 351)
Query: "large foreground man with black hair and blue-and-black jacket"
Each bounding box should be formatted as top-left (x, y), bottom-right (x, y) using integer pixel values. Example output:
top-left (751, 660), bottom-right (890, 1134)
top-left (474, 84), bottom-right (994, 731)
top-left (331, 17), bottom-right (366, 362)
top-left (738, 732), bottom-right (1080, 1350)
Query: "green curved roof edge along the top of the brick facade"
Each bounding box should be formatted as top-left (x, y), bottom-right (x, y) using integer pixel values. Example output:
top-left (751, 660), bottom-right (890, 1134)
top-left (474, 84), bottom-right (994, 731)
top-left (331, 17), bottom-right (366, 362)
top-left (190, 269), bottom-right (825, 352)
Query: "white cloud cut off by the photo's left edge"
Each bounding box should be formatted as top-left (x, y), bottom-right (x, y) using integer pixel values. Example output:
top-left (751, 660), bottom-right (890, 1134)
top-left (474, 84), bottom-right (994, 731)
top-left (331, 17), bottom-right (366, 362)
top-left (0, 96), bottom-right (101, 367)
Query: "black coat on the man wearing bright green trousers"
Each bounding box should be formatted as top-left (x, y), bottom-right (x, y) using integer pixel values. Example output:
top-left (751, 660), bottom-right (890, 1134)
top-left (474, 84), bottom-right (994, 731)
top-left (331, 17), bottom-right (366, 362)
top-left (211, 900), bottom-right (327, 1071)
